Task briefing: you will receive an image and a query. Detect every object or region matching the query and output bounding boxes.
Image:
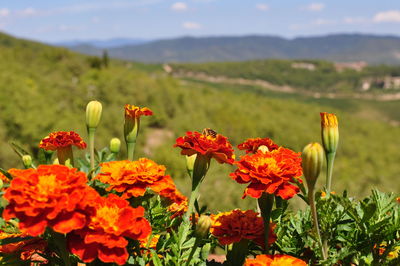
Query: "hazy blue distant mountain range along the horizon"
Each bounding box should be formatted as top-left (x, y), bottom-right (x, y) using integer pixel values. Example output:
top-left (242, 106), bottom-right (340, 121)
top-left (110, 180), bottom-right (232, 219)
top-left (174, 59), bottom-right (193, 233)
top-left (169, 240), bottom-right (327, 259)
top-left (64, 34), bottom-right (400, 64)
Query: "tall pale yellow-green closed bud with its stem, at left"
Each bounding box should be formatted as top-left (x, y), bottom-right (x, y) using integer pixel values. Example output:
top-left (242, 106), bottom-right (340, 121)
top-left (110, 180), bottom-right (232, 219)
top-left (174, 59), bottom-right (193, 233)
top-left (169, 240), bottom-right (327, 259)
top-left (86, 101), bottom-right (103, 174)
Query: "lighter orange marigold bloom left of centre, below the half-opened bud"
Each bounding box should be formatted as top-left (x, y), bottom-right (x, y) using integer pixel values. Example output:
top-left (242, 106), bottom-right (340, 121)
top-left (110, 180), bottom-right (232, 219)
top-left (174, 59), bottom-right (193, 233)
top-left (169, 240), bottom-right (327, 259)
top-left (95, 158), bottom-right (184, 202)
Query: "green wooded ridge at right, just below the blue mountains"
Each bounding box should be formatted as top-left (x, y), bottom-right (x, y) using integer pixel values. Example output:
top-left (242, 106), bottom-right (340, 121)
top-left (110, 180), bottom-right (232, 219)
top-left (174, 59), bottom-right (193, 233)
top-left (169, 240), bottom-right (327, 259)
top-left (172, 59), bottom-right (400, 93)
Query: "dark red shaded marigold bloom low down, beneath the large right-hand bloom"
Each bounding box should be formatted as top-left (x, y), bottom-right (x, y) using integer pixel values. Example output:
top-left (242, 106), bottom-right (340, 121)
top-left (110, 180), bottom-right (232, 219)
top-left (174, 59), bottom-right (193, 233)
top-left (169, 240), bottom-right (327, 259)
top-left (210, 210), bottom-right (276, 246)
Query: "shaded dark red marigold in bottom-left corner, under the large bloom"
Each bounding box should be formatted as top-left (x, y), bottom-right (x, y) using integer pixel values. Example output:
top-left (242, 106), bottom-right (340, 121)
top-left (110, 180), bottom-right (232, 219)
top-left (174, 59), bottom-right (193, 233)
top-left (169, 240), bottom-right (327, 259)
top-left (0, 232), bottom-right (47, 262)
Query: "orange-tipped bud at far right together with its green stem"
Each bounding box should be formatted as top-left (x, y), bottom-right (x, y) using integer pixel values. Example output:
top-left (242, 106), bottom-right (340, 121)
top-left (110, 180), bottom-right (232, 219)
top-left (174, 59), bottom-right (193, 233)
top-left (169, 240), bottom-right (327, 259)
top-left (320, 113), bottom-right (339, 195)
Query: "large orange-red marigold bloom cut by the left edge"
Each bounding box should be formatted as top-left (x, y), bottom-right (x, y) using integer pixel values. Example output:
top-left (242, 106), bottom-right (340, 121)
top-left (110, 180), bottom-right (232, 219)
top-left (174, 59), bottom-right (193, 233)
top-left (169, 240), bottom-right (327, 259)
top-left (3, 165), bottom-right (98, 236)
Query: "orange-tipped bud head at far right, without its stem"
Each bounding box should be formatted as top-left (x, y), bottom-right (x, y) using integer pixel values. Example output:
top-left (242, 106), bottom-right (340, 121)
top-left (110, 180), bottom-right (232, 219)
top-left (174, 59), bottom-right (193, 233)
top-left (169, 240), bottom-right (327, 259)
top-left (320, 112), bottom-right (339, 153)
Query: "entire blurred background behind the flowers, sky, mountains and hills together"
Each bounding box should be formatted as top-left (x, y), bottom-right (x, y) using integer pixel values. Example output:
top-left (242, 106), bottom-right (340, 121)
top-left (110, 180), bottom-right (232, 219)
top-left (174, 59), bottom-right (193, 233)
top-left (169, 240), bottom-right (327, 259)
top-left (0, 0), bottom-right (400, 210)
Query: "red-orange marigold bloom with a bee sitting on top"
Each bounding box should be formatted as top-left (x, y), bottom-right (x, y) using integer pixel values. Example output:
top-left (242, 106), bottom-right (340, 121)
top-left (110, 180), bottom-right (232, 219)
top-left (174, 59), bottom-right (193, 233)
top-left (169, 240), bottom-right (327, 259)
top-left (174, 131), bottom-right (235, 164)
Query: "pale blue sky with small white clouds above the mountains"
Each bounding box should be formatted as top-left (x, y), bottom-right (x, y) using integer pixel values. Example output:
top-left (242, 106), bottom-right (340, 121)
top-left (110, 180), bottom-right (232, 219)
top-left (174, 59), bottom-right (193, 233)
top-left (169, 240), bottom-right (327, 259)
top-left (0, 0), bottom-right (400, 42)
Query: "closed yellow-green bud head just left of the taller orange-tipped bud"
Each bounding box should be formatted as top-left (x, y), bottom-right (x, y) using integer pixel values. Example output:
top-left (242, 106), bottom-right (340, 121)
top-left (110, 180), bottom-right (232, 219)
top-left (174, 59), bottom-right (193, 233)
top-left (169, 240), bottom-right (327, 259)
top-left (301, 142), bottom-right (324, 189)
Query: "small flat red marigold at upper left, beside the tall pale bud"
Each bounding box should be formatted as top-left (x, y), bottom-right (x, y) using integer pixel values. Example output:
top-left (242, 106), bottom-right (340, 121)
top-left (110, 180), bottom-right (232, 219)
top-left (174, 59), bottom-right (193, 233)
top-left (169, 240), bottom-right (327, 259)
top-left (39, 131), bottom-right (86, 151)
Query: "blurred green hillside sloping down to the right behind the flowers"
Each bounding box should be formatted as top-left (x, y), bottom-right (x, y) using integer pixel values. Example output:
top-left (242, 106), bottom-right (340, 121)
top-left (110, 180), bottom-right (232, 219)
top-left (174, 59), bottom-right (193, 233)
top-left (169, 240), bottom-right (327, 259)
top-left (0, 34), bottom-right (400, 210)
